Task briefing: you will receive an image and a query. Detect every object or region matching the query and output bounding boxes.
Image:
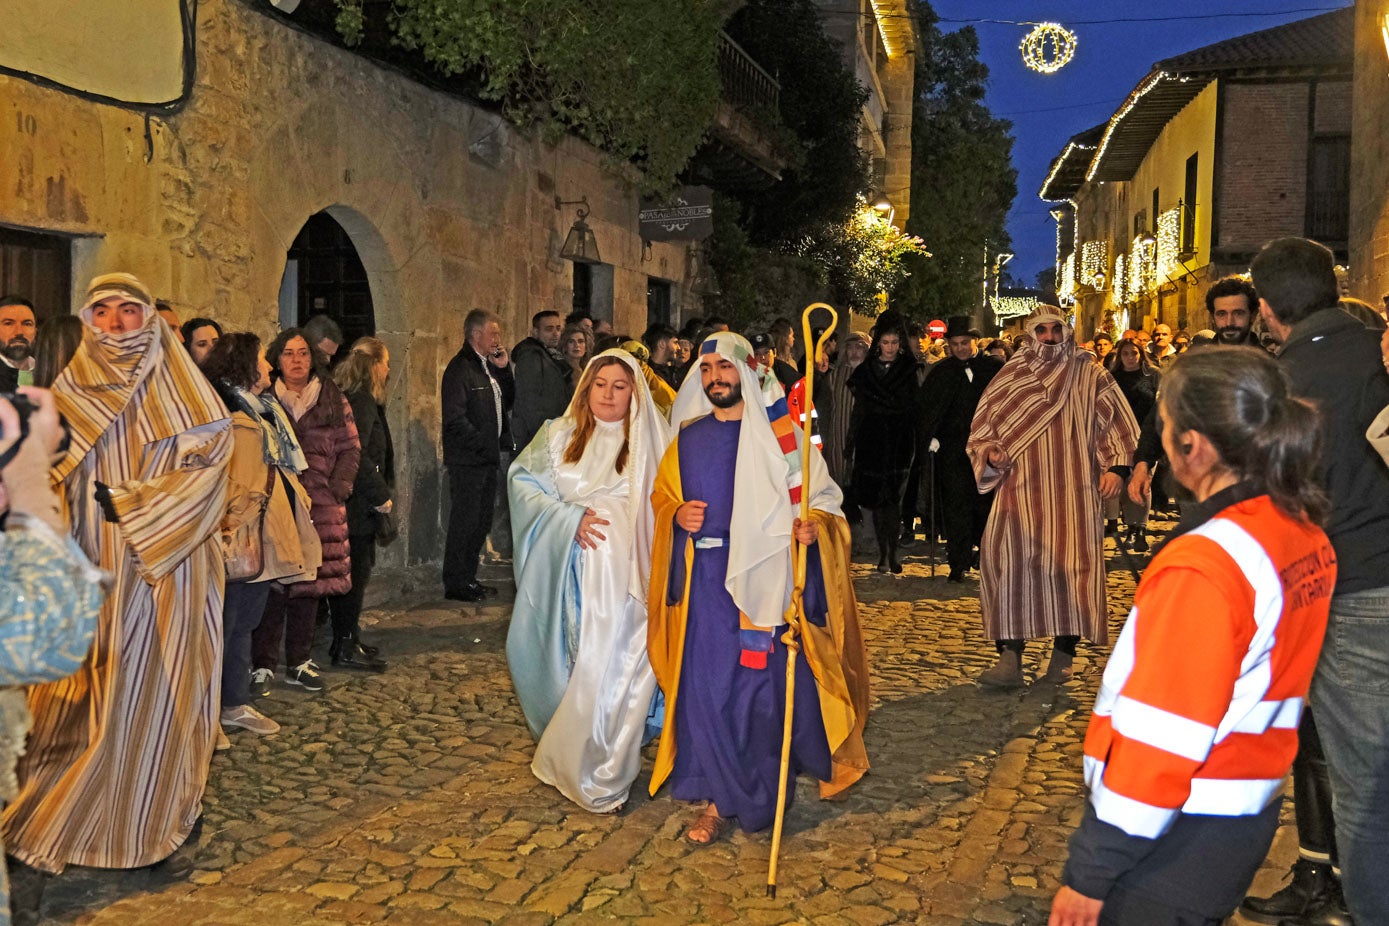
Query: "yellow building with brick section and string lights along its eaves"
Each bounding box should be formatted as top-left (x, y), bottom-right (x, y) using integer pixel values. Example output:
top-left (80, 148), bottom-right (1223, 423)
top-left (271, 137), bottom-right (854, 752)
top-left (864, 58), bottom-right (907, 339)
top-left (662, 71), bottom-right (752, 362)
top-left (1040, 10), bottom-right (1351, 336)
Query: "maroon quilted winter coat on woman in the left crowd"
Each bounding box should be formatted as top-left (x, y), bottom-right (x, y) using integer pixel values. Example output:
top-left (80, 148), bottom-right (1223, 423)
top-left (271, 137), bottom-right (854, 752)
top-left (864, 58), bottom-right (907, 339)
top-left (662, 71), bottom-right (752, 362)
top-left (279, 376), bottom-right (361, 598)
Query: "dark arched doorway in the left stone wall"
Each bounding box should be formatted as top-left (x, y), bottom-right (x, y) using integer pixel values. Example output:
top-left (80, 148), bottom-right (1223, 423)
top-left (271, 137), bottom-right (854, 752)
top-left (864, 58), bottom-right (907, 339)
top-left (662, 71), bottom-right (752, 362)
top-left (279, 211), bottom-right (376, 344)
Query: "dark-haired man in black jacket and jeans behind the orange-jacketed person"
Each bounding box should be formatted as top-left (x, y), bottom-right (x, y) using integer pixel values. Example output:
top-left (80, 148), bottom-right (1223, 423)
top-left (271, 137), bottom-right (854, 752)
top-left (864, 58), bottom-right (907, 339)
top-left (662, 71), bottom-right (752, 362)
top-left (1250, 237), bottom-right (1389, 923)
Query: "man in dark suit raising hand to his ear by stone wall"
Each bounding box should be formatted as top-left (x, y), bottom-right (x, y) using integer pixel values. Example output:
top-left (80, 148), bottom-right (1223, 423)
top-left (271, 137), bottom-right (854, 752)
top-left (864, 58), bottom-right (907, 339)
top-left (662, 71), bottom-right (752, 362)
top-left (440, 308), bottom-right (515, 601)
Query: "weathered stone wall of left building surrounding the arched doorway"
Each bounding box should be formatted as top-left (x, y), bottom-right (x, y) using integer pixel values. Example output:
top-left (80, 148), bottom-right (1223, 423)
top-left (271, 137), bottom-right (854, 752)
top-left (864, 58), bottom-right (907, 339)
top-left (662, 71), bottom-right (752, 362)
top-left (0, 0), bottom-right (697, 566)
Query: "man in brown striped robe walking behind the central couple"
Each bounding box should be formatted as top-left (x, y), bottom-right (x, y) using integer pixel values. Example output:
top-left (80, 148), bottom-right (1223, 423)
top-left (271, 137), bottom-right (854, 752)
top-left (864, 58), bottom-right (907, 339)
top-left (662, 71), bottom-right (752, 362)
top-left (965, 305), bottom-right (1138, 687)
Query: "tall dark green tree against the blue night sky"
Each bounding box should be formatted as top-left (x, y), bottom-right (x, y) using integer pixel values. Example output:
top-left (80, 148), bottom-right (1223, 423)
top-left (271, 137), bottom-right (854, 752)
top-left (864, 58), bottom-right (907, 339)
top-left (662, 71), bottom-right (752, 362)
top-left (893, 0), bottom-right (1018, 318)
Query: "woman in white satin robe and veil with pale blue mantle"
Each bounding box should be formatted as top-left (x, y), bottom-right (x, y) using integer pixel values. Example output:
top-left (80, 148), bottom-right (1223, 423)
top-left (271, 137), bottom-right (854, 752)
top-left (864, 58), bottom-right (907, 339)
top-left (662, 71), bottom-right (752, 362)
top-left (507, 350), bottom-right (669, 814)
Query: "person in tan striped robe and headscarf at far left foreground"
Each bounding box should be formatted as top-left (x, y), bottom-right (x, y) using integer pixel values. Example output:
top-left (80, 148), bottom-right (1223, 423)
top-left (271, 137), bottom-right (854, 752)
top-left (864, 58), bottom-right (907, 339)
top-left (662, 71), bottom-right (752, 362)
top-left (3, 273), bottom-right (232, 899)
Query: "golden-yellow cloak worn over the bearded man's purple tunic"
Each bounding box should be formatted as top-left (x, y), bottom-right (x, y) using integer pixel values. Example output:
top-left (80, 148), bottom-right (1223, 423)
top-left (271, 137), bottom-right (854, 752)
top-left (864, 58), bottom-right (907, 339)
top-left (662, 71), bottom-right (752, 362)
top-left (646, 436), bottom-right (868, 798)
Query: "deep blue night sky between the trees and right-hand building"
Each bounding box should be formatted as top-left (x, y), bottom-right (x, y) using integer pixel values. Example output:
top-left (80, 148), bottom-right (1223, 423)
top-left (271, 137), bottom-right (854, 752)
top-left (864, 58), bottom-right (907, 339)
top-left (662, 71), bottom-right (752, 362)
top-left (926, 0), bottom-right (1350, 285)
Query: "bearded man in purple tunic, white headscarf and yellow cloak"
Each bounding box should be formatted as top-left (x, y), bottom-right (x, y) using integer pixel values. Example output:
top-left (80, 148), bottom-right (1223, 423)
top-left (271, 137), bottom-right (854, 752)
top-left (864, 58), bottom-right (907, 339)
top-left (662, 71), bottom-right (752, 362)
top-left (647, 332), bottom-right (868, 845)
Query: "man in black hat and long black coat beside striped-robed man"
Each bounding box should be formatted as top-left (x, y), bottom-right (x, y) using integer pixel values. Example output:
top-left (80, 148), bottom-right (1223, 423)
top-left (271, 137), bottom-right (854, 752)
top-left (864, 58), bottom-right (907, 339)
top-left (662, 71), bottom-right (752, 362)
top-left (918, 315), bottom-right (1003, 582)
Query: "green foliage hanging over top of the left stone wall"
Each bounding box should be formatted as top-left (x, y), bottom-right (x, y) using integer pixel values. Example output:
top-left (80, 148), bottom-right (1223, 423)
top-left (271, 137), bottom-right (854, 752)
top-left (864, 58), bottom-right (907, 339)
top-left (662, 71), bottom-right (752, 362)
top-left (336, 0), bottom-right (728, 192)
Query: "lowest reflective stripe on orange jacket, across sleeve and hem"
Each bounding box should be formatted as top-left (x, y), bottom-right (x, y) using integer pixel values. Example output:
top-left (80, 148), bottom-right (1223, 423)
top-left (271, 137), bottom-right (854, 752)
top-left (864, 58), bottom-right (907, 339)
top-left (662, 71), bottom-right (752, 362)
top-left (1085, 755), bottom-right (1286, 839)
